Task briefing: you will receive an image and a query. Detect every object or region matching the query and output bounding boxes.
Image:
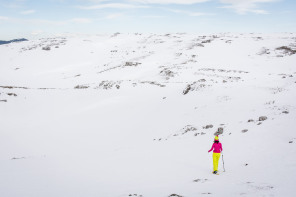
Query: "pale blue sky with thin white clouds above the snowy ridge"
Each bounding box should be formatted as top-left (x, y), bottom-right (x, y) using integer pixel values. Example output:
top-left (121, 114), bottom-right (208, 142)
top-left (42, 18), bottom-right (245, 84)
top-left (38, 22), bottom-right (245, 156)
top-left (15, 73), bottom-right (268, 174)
top-left (0, 0), bottom-right (296, 40)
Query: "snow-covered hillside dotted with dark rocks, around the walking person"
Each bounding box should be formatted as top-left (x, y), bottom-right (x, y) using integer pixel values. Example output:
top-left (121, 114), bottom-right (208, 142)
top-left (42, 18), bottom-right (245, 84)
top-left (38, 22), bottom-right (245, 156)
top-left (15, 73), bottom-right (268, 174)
top-left (0, 33), bottom-right (296, 197)
